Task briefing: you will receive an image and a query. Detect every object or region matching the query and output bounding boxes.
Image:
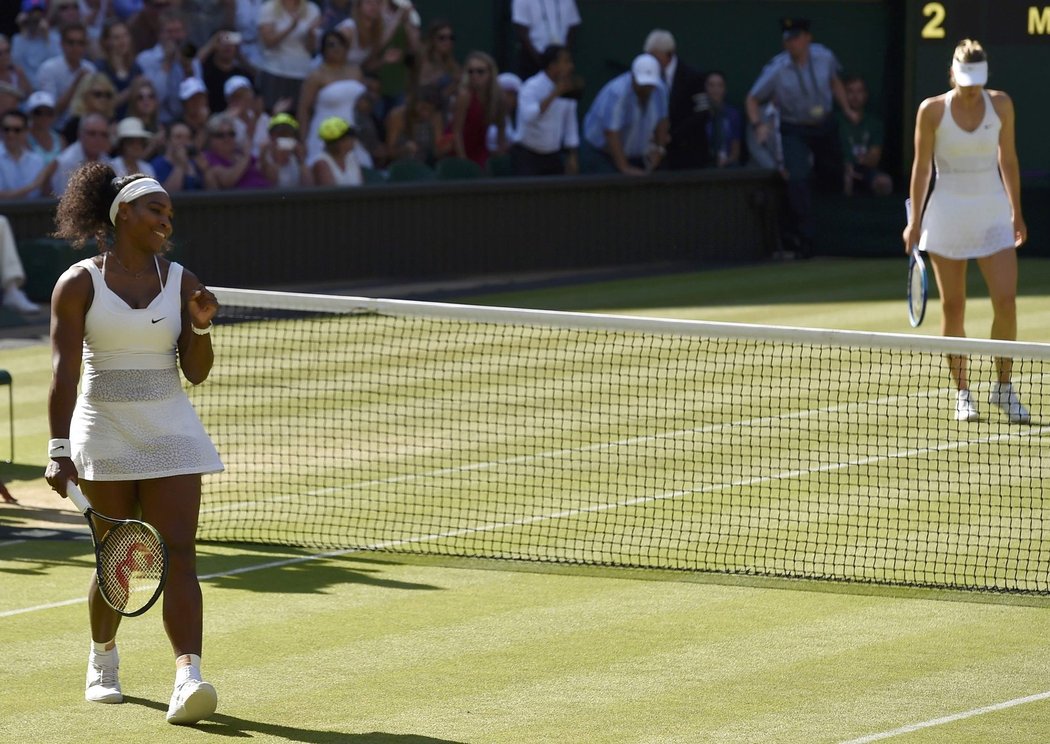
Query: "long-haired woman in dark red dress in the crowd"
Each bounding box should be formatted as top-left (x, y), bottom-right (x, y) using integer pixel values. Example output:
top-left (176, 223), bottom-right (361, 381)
top-left (452, 51), bottom-right (506, 167)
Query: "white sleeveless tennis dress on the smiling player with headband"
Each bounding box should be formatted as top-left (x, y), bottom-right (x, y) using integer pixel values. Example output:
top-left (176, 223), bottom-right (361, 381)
top-left (69, 254), bottom-right (223, 481)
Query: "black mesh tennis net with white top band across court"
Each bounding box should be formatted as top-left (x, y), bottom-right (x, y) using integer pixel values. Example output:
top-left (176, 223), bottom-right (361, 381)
top-left (190, 290), bottom-right (1050, 593)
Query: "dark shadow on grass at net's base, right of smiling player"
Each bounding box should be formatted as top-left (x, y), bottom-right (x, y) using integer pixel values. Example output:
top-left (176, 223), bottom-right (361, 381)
top-left (201, 545), bottom-right (441, 594)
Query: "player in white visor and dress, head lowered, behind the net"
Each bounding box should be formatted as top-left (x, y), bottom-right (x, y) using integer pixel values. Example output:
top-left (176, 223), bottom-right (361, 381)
top-left (904, 39), bottom-right (1030, 423)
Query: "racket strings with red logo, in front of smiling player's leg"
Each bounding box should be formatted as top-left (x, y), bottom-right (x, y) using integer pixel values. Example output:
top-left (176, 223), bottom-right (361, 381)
top-left (99, 523), bottom-right (165, 611)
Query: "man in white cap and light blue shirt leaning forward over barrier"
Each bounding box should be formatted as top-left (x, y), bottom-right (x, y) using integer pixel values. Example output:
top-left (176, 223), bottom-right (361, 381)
top-left (580, 55), bottom-right (669, 175)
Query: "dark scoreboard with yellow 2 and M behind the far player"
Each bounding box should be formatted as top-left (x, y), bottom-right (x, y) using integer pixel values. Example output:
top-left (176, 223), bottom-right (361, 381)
top-left (904, 0), bottom-right (1050, 174)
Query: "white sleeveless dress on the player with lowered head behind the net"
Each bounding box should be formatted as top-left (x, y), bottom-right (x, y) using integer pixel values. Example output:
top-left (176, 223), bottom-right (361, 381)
top-left (919, 90), bottom-right (1013, 259)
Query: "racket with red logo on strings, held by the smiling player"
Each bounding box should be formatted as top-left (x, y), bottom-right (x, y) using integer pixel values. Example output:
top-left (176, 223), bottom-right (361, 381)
top-left (66, 481), bottom-right (168, 617)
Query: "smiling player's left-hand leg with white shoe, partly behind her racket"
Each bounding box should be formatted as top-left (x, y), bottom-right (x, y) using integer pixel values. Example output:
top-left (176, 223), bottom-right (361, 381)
top-left (80, 480), bottom-right (139, 703)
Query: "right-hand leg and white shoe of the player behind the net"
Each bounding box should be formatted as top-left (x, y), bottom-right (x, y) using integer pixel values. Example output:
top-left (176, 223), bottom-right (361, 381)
top-left (978, 248), bottom-right (1030, 424)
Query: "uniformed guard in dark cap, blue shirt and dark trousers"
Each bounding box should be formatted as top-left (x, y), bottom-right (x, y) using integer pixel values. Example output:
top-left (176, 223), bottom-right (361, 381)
top-left (746, 18), bottom-right (860, 257)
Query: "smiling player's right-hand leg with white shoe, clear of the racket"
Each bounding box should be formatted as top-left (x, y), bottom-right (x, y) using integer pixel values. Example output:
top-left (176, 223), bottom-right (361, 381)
top-left (140, 474), bottom-right (216, 723)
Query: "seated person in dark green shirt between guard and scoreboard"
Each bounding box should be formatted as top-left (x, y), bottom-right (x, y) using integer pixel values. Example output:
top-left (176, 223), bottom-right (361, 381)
top-left (836, 75), bottom-right (894, 196)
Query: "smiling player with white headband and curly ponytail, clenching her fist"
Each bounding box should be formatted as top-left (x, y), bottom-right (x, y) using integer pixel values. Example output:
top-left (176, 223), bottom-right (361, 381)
top-left (44, 163), bottom-right (223, 724)
